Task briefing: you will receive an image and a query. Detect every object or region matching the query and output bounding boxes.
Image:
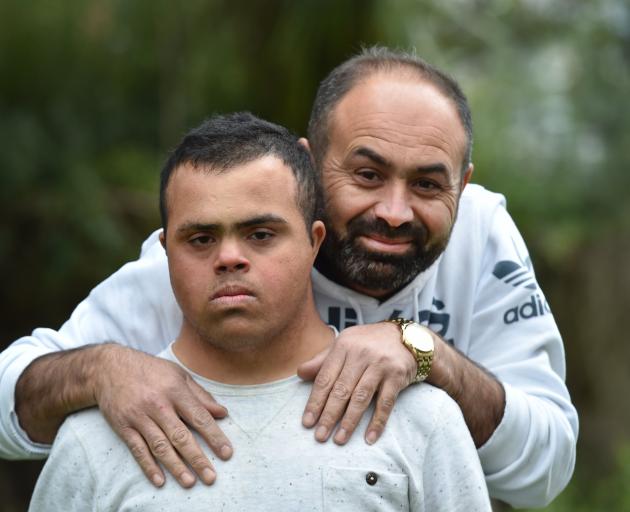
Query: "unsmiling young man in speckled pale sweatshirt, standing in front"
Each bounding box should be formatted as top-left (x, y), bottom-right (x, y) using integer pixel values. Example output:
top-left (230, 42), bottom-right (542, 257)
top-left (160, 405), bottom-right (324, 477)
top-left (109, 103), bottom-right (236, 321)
top-left (31, 114), bottom-right (490, 512)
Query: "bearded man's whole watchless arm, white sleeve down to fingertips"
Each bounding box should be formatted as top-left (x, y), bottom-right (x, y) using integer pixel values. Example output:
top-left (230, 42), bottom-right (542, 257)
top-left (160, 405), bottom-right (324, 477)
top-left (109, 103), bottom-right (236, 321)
top-left (0, 232), bottom-right (230, 484)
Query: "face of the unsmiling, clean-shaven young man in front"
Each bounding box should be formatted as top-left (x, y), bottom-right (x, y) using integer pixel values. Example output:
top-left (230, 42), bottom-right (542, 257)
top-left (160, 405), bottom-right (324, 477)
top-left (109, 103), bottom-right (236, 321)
top-left (165, 156), bottom-right (324, 351)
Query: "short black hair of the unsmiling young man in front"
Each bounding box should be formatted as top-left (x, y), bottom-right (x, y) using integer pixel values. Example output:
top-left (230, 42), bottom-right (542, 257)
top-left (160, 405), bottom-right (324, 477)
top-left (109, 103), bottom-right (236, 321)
top-left (160, 112), bottom-right (321, 233)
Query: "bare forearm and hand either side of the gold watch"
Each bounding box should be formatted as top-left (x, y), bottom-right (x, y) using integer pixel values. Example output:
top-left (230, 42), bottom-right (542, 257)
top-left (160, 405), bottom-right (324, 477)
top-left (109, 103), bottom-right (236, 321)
top-left (300, 322), bottom-right (505, 446)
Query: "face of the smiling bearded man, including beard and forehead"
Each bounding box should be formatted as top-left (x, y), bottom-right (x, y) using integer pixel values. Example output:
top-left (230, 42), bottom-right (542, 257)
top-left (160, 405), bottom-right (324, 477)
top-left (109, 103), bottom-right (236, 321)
top-left (321, 74), bottom-right (472, 298)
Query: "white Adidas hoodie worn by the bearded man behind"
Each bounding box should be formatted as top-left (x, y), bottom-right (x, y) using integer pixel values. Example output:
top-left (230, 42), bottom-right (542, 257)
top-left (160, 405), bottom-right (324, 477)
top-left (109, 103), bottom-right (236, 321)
top-left (0, 185), bottom-right (578, 507)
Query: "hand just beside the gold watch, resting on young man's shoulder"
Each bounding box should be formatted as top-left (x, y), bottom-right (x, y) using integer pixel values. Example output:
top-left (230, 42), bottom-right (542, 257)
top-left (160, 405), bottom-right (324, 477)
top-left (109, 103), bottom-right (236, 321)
top-left (298, 322), bottom-right (417, 444)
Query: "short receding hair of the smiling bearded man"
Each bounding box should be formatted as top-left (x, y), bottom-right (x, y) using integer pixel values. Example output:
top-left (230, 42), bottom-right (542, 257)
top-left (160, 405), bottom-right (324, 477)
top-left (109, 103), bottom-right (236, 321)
top-left (308, 46), bottom-right (473, 173)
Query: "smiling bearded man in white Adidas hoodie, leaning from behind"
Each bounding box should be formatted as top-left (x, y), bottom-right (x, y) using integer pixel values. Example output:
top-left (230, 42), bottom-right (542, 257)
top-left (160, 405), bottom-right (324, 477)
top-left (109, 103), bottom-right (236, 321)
top-left (0, 49), bottom-right (577, 507)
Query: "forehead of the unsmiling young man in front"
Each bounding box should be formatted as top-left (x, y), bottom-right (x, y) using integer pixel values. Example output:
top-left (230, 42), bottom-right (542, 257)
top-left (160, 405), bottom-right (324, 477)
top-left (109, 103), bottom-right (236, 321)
top-left (166, 155), bottom-right (301, 225)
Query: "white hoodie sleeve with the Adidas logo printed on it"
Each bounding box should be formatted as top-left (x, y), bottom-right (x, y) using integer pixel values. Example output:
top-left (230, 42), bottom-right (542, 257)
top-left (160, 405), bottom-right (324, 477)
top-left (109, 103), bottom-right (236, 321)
top-left (468, 200), bottom-right (578, 507)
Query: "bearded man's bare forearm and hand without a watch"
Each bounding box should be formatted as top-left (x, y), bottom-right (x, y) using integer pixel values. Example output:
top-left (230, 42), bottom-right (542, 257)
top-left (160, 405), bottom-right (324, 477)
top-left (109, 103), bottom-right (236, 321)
top-left (16, 344), bottom-right (232, 487)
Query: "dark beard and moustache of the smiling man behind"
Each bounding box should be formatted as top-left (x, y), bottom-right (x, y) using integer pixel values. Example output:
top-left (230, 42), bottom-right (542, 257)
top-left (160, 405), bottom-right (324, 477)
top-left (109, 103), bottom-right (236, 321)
top-left (321, 217), bottom-right (450, 292)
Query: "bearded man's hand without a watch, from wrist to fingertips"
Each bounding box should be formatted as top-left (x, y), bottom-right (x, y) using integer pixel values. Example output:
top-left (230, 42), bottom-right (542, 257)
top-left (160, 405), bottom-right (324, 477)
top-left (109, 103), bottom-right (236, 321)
top-left (94, 344), bottom-right (232, 487)
